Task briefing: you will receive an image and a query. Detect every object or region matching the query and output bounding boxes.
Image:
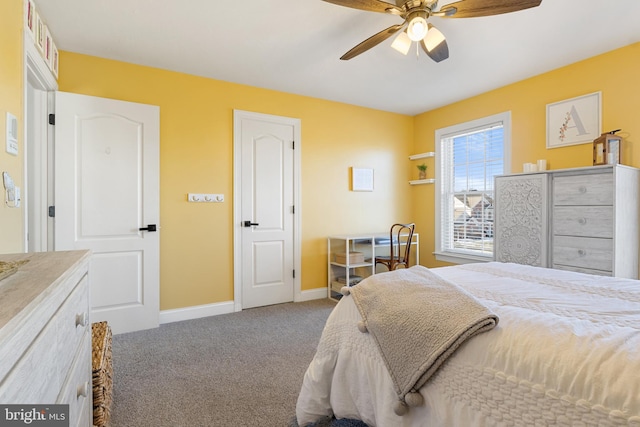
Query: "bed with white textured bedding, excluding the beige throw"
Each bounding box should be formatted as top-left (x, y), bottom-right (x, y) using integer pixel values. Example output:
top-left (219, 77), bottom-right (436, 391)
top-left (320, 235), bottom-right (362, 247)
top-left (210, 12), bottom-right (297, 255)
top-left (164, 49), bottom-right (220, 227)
top-left (296, 262), bottom-right (640, 427)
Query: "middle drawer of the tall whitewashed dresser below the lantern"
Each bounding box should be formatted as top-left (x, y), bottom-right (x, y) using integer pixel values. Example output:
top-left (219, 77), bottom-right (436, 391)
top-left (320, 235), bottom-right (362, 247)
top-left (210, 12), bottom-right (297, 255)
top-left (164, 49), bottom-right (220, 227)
top-left (553, 206), bottom-right (613, 239)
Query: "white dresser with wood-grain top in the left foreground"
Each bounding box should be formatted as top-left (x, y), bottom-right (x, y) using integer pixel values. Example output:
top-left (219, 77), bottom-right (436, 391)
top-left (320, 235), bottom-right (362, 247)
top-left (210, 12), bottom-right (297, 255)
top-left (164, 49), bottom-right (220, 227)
top-left (0, 251), bottom-right (93, 427)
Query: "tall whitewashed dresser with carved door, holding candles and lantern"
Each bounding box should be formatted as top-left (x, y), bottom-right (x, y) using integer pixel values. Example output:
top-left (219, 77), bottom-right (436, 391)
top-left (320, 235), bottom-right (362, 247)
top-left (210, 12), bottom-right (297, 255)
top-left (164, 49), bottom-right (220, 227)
top-left (494, 165), bottom-right (640, 279)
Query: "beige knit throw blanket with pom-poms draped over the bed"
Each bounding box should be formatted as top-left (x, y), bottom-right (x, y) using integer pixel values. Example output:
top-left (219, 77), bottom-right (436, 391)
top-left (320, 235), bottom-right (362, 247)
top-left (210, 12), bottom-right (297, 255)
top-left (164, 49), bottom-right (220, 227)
top-left (349, 266), bottom-right (498, 415)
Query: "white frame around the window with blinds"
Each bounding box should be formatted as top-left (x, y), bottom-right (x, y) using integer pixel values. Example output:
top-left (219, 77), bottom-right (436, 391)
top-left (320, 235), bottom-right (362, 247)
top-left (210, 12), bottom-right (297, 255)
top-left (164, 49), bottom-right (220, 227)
top-left (434, 111), bottom-right (511, 264)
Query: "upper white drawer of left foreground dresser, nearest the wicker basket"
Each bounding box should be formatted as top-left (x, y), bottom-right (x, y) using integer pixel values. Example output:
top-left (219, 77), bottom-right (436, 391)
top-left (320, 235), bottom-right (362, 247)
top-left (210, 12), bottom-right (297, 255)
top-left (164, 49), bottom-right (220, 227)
top-left (55, 275), bottom-right (91, 378)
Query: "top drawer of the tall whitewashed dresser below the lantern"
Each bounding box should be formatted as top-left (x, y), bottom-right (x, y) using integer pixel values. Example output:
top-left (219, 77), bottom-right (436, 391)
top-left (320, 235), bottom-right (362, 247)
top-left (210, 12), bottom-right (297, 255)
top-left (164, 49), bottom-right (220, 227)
top-left (553, 173), bottom-right (614, 206)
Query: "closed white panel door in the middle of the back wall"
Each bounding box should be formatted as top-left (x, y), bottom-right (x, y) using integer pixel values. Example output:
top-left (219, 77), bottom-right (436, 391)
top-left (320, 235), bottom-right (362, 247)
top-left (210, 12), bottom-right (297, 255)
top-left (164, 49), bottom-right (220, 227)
top-left (234, 111), bottom-right (299, 308)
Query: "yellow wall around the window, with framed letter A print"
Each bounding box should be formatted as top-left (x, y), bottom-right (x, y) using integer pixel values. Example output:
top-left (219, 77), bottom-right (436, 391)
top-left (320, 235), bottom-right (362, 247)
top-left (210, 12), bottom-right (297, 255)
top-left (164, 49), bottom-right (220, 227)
top-left (412, 43), bottom-right (640, 267)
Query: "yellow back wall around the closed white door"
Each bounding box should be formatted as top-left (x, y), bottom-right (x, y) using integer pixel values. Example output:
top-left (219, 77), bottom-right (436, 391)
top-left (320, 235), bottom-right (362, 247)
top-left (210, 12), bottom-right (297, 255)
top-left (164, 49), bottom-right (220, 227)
top-left (58, 52), bottom-right (413, 310)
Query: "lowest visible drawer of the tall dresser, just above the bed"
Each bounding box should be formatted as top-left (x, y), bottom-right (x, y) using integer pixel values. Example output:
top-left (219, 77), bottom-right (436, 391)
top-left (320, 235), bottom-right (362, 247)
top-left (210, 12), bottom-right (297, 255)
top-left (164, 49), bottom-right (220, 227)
top-left (552, 236), bottom-right (613, 271)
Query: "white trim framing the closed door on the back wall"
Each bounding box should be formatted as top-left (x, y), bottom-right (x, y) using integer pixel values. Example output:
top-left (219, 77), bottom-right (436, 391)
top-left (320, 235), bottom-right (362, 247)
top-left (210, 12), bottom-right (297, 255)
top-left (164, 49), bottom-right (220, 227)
top-left (233, 110), bottom-right (302, 311)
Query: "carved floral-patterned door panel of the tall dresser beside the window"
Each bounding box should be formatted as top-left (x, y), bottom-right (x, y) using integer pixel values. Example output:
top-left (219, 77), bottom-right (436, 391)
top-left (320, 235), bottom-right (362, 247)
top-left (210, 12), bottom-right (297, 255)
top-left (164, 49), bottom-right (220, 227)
top-left (493, 173), bottom-right (548, 267)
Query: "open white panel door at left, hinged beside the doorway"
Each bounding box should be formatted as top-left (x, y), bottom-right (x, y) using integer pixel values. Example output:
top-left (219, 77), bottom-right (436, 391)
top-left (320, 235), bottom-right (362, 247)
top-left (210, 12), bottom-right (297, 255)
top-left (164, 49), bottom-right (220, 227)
top-left (54, 92), bottom-right (160, 333)
